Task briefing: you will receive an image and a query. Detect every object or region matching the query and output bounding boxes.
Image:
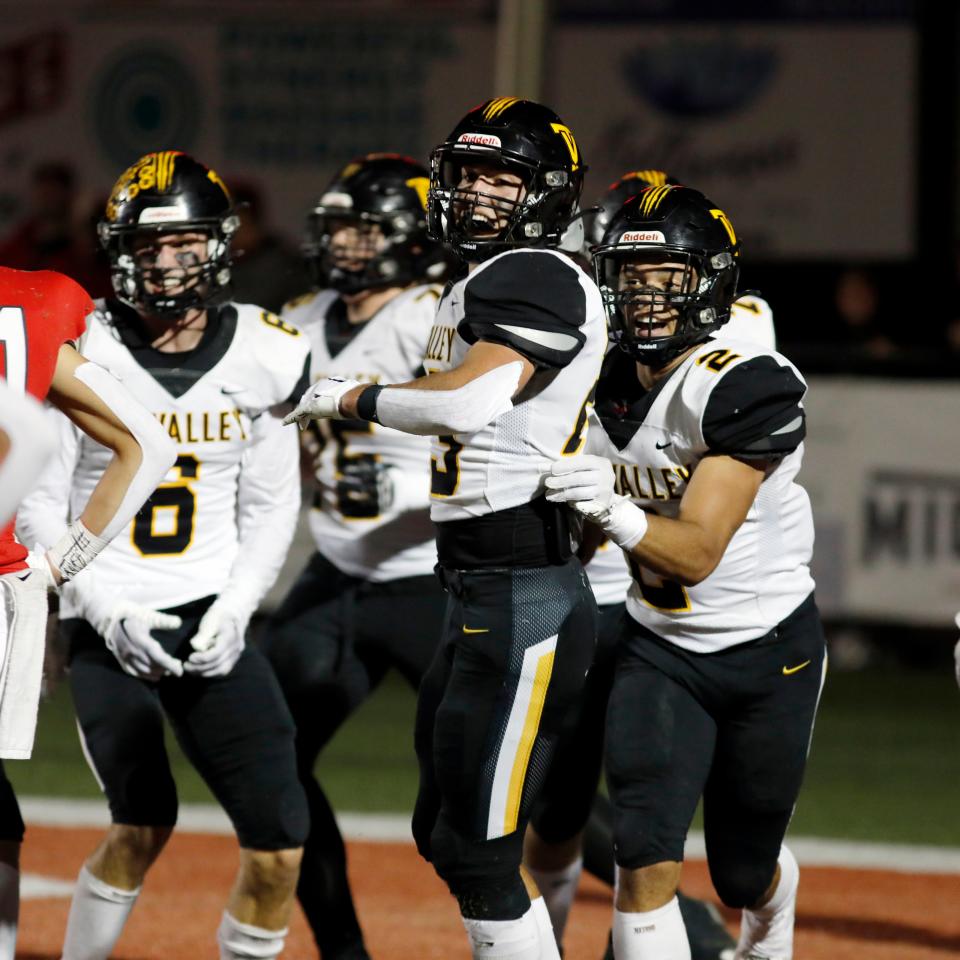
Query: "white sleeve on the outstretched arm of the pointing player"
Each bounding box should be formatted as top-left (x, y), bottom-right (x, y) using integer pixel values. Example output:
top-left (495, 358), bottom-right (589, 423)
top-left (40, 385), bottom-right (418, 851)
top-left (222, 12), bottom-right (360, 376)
top-left (377, 360), bottom-right (523, 437)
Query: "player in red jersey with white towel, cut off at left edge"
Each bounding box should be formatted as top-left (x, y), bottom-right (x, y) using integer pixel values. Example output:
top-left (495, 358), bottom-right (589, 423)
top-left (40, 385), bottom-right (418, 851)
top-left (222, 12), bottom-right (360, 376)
top-left (0, 267), bottom-right (175, 960)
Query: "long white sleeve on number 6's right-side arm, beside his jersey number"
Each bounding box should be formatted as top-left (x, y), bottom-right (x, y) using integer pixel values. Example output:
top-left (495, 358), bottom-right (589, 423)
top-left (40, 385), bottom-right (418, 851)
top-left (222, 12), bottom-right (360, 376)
top-left (218, 410), bottom-right (300, 622)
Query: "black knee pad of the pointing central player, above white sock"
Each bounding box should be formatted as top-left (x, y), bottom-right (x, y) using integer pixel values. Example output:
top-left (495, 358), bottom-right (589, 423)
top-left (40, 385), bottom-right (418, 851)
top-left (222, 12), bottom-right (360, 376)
top-left (429, 814), bottom-right (530, 920)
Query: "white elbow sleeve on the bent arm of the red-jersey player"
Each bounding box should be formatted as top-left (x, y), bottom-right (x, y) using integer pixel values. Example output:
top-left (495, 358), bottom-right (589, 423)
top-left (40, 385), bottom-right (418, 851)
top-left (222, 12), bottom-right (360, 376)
top-left (74, 361), bottom-right (177, 541)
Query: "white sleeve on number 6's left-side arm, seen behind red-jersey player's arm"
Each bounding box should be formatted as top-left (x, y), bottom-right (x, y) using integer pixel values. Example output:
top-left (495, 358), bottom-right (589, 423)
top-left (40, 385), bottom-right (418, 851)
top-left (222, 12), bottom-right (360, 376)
top-left (17, 408), bottom-right (80, 547)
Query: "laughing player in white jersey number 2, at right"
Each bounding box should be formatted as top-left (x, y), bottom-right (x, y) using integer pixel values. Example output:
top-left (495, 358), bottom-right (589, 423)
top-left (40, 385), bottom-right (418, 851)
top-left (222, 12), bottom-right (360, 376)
top-left (547, 184), bottom-right (826, 960)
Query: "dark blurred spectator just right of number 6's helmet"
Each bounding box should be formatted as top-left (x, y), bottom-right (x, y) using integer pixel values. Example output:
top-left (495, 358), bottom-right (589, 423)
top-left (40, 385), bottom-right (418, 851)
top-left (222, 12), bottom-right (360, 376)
top-left (231, 184), bottom-right (310, 312)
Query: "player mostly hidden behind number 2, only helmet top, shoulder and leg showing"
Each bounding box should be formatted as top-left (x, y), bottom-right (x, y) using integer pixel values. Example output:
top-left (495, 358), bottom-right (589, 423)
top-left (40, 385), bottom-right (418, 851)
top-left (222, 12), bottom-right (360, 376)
top-left (524, 169), bottom-right (776, 960)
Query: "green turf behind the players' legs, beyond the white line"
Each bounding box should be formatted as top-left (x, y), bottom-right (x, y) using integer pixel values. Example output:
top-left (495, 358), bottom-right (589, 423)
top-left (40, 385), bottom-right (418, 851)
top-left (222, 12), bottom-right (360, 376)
top-left (6, 666), bottom-right (960, 846)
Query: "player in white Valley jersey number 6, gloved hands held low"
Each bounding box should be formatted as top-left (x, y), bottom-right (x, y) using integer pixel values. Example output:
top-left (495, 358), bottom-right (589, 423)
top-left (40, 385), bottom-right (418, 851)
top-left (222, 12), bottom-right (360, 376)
top-left (16, 151), bottom-right (309, 960)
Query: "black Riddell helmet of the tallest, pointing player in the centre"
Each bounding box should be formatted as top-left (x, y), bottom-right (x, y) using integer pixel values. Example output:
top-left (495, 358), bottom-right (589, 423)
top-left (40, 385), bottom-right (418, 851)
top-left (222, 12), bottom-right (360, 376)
top-left (427, 97), bottom-right (587, 262)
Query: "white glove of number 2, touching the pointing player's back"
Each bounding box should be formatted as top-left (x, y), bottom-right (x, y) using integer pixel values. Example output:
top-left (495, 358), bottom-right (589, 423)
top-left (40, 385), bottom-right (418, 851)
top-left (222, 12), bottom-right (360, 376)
top-left (544, 453), bottom-right (647, 550)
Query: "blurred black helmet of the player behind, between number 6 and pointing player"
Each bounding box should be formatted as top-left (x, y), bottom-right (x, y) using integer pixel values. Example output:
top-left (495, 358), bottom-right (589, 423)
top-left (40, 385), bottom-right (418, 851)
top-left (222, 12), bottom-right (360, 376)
top-left (303, 153), bottom-right (447, 293)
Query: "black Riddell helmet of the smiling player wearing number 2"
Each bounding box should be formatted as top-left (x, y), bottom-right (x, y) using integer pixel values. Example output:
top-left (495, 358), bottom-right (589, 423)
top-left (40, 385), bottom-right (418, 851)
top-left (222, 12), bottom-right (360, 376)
top-left (593, 184), bottom-right (740, 369)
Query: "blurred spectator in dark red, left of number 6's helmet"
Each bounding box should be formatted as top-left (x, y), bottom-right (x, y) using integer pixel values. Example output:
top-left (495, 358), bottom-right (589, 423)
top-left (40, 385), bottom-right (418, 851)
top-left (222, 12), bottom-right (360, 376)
top-left (0, 162), bottom-right (110, 296)
